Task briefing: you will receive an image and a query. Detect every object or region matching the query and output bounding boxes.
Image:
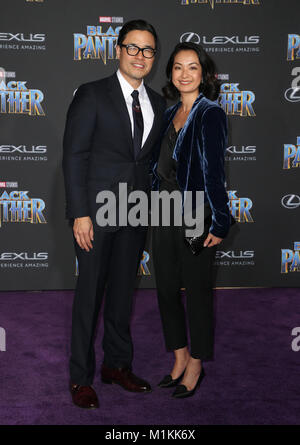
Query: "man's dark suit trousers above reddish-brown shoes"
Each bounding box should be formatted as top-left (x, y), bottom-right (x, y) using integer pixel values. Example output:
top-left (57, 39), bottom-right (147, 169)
top-left (70, 226), bottom-right (146, 385)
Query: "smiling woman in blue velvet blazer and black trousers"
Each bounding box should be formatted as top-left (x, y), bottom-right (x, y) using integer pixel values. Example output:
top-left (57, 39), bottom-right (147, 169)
top-left (153, 42), bottom-right (231, 398)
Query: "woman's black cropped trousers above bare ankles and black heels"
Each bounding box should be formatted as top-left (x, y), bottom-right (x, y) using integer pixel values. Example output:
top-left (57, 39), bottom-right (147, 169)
top-left (153, 222), bottom-right (216, 360)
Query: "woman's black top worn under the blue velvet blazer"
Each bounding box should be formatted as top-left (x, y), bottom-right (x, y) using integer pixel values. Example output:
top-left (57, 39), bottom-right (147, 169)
top-left (157, 122), bottom-right (181, 190)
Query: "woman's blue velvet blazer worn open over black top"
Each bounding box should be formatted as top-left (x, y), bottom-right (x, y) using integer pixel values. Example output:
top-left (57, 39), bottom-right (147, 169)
top-left (153, 93), bottom-right (231, 238)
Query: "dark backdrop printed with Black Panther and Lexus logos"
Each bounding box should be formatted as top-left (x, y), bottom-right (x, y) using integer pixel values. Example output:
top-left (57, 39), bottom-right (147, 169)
top-left (0, 0), bottom-right (300, 290)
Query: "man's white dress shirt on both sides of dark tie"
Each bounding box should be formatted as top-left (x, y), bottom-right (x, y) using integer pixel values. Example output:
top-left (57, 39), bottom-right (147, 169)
top-left (117, 70), bottom-right (154, 147)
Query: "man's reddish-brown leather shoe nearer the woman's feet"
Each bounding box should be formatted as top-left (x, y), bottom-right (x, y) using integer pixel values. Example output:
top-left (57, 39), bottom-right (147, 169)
top-left (101, 365), bottom-right (152, 392)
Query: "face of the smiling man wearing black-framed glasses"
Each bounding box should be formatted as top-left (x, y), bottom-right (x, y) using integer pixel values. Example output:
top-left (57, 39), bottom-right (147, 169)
top-left (116, 30), bottom-right (155, 83)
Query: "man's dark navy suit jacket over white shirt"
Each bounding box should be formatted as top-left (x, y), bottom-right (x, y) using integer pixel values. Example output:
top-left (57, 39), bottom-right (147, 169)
top-left (63, 74), bottom-right (166, 227)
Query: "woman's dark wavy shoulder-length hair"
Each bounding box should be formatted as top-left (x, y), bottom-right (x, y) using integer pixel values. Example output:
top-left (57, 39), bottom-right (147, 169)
top-left (162, 42), bottom-right (220, 100)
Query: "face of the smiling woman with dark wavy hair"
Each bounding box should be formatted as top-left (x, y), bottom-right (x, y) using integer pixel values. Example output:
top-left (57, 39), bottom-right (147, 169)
top-left (172, 49), bottom-right (202, 94)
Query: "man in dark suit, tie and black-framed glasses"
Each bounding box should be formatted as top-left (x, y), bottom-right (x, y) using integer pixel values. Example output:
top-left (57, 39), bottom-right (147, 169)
top-left (63, 20), bottom-right (165, 408)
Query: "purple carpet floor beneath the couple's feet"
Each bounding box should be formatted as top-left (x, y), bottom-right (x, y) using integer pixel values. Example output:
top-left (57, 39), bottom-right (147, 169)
top-left (0, 288), bottom-right (300, 425)
